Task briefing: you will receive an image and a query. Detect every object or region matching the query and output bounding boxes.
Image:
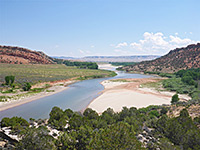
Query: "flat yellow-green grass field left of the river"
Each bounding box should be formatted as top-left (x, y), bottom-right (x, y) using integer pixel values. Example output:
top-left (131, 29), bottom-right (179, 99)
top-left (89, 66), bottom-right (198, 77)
top-left (0, 64), bottom-right (115, 84)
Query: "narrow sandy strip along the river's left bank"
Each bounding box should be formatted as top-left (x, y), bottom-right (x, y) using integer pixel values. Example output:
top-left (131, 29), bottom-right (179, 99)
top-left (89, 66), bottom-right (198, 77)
top-left (0, 80), bottom-right (76, 111)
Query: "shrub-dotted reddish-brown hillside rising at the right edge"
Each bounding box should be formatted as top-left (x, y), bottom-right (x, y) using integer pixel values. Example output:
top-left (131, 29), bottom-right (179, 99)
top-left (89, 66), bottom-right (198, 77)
top-left (122, 43), bottom-right (200, 73)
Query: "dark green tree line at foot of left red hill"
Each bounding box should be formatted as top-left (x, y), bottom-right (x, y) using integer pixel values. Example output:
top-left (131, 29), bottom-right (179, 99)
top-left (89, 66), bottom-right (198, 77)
top-left (54, 59), bottom-right (98, 69)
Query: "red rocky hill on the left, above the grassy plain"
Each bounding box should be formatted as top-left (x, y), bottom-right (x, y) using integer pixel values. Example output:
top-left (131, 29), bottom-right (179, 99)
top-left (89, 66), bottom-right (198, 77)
top-left (0, 46), bottom-right (54, 64)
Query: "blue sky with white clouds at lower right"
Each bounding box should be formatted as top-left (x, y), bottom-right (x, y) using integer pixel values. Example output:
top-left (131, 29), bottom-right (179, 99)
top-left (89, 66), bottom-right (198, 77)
top-left (0, 0), bottom-right (200, 57)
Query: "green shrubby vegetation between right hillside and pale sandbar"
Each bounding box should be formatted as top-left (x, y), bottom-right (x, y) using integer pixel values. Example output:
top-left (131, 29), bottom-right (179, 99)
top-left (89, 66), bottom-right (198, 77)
top-left (142, 68), bottom-right (200, 103)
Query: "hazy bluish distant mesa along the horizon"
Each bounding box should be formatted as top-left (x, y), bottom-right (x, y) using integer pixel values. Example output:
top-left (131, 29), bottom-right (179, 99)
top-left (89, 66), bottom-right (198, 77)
top-left (53, 55), bottom-right (159, 62)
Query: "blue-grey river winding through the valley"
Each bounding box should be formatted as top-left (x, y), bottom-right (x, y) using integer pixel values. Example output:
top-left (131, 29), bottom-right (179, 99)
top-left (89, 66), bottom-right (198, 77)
top-left (0, 67), bottom-right (152, 120)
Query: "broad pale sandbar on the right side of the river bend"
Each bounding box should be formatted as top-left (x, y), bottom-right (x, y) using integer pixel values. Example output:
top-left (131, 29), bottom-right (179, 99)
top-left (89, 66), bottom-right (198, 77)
top-left (88, 78), bottom-right (189, 113)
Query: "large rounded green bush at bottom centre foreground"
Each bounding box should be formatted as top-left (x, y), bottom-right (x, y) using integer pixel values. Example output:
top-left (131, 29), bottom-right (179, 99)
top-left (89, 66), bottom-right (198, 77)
top-left (88, 122), bottom-right (144, 150)
